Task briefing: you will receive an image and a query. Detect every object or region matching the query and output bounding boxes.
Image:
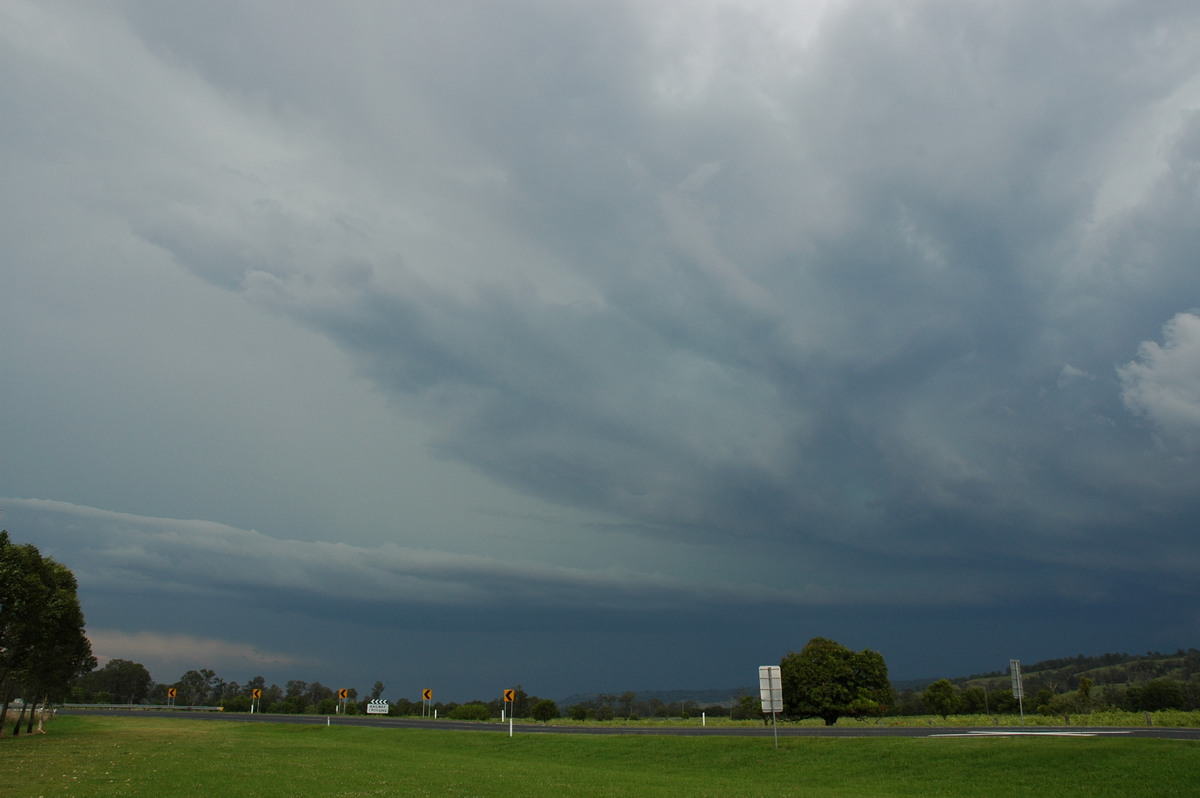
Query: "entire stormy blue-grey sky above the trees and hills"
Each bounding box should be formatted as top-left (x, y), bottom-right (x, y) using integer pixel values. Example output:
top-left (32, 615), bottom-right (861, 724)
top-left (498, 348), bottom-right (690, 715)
top-left (0, 0), bottom-right (1200, 701)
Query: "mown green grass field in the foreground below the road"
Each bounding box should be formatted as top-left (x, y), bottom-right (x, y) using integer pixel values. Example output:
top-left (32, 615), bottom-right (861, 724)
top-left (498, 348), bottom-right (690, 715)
top-left (0, 716), bottom-right (1200, 798)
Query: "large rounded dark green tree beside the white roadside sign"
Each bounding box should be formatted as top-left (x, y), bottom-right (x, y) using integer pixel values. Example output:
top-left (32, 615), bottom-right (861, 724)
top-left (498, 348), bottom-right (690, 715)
top-left (780, 637), bottom-right (892, 726)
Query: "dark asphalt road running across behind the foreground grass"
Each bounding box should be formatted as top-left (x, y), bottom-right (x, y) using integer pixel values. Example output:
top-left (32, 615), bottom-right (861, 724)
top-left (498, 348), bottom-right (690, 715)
top-left (59, 709), bottom-right (1200, 740)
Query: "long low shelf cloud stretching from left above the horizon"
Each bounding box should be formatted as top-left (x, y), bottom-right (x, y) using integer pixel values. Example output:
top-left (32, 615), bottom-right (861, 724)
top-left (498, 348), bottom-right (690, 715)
top-left (2, 498), bottom-right (825, 613)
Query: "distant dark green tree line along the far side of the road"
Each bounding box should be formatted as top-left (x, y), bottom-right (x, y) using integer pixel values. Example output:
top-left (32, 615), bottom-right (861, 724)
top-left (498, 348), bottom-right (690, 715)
top-left (72, 637), bottom-right (1200, 725)
